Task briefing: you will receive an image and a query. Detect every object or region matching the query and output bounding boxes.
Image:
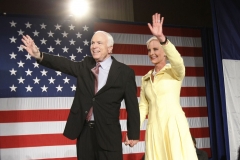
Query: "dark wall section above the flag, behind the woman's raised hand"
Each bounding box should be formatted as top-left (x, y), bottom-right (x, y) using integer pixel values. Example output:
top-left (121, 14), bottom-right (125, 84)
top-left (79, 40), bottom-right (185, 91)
top-left (133, 0), bottom-right (212, 27)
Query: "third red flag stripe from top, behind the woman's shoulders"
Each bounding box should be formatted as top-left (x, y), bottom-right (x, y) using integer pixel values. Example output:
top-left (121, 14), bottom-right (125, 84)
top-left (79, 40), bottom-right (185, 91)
top-left (129, 65), bottom-right (204, 77)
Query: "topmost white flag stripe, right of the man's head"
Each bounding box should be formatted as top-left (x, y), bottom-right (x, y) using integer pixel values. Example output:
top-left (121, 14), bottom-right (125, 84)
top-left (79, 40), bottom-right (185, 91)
top-left (110, 33), bottom-right (202, 47)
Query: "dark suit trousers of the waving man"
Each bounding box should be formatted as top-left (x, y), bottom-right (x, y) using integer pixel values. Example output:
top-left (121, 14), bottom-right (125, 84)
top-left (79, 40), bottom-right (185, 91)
top-left (77, 121), bottom-right (123, 160)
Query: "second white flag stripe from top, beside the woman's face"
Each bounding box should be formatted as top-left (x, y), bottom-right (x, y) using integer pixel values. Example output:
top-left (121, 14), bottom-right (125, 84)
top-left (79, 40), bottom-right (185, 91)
top-left (112, 54), bottom-right (203, 67)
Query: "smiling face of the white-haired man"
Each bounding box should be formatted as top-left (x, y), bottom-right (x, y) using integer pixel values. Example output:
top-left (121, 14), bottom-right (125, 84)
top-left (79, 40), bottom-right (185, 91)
top-left (90, 33), bottom-right (113, 62)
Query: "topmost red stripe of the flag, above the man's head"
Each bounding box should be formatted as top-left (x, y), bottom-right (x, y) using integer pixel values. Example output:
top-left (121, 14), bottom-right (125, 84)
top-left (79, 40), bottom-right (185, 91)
top-left (94, 22), bottom-right (201, 38)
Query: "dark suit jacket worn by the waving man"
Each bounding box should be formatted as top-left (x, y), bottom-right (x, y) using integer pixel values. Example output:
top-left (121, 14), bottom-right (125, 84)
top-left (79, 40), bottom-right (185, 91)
top-left (39, 53), bottom-right (140, 151)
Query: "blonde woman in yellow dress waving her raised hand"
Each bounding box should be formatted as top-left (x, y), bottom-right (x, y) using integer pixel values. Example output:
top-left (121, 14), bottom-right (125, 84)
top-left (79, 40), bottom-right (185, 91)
top-left (139, 13), bottom-right (197, 160)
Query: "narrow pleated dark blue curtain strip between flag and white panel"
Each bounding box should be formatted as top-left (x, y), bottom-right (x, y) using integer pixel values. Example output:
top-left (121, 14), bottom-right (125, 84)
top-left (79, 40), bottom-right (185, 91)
top-left (202, 5), bottom-right (230, 160)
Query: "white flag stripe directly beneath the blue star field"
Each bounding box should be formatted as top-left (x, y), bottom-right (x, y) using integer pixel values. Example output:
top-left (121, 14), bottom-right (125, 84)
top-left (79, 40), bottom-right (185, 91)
top-left (0, 97), bottom-right (207, 111)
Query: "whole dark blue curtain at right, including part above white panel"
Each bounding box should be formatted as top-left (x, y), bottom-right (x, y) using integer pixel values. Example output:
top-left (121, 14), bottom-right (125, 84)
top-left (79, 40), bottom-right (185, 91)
top-left (206, 0), bottom-right (240, 160)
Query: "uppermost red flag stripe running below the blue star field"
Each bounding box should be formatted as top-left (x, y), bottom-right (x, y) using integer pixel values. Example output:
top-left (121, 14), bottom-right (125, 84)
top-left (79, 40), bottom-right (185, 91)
top-left (0, 107), bottom-right (207, 123)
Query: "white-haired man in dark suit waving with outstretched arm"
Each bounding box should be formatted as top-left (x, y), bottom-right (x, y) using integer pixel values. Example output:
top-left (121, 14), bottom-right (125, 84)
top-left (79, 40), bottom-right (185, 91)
top-left (22, 31), bottom-right (140, 160)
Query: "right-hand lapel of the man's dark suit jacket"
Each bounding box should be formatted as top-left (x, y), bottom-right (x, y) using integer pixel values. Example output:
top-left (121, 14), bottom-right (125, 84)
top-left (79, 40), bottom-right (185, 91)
top-left (96, 57), bottom-right (121, 95)
